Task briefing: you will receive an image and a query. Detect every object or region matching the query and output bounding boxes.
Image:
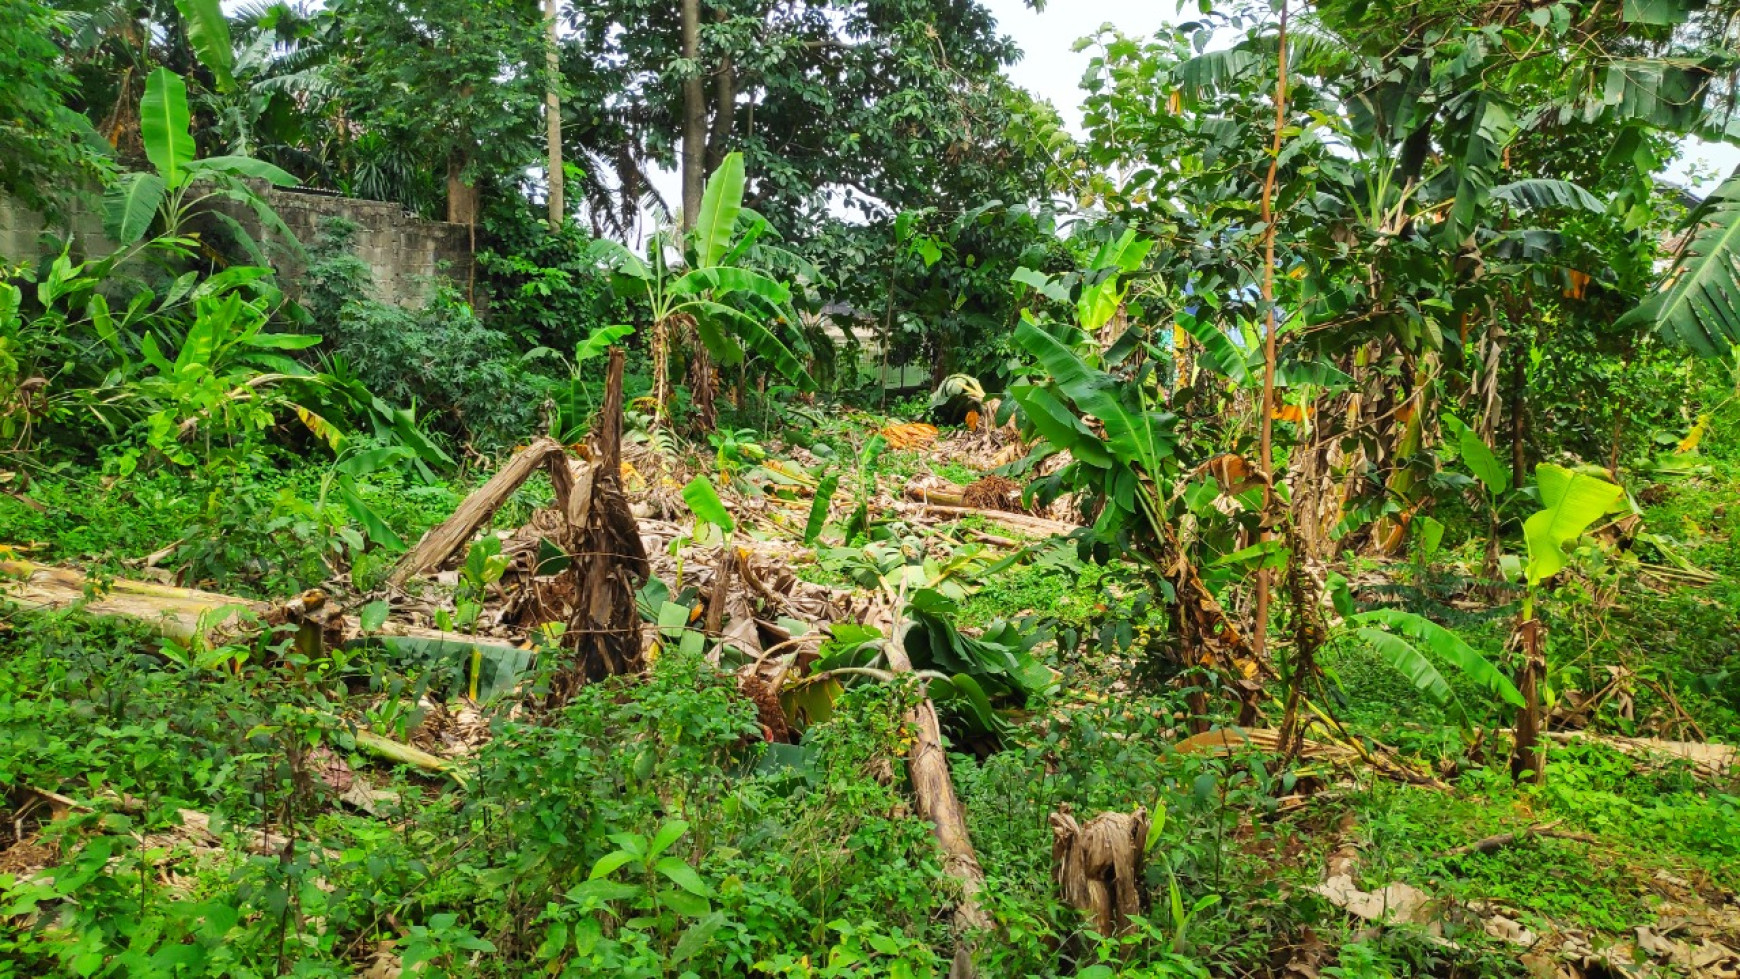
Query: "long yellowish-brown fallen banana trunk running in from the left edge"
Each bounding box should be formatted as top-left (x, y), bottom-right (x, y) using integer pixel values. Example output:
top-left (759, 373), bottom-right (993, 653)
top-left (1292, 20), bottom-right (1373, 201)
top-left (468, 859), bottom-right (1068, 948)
top-left (0, 560), bottom-right (520, 654)
